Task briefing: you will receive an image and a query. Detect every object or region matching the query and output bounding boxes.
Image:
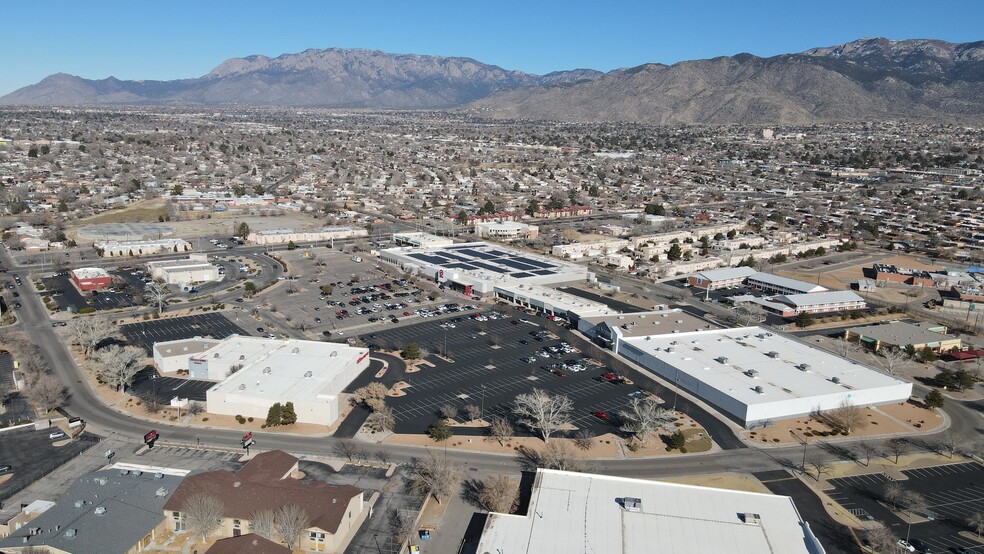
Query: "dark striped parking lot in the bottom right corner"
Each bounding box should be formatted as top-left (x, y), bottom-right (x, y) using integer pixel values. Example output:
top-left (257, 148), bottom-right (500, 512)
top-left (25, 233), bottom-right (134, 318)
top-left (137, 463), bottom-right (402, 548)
top-left (829, 462), bottom-right (984, 552)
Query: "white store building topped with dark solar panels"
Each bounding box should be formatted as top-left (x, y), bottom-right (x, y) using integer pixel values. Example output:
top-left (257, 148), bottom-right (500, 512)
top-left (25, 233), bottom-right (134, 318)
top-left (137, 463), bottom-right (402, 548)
top-left (380, 242), bottom-right (594, 295)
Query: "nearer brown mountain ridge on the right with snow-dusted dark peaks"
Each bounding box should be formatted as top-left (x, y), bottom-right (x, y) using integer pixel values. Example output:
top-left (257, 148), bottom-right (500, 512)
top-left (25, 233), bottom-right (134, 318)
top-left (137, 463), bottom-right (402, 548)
top-left (468, 38), bottom-right (984, 125)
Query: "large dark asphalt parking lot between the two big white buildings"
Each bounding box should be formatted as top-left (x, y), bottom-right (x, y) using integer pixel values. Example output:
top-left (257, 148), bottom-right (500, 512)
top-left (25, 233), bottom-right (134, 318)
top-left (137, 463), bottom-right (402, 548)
top-left (350, 312), bottom-right (741, 448)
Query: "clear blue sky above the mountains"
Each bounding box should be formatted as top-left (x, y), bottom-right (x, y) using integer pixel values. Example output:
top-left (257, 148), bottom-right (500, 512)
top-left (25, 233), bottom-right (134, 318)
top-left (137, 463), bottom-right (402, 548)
top-left (0, 0), bottom-right (984, 95)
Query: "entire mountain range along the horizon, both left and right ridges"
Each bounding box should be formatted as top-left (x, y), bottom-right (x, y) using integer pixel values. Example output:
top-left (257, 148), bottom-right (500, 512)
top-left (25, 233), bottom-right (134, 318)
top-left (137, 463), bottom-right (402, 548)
top-left (0, 38), bottom-right (984, 124)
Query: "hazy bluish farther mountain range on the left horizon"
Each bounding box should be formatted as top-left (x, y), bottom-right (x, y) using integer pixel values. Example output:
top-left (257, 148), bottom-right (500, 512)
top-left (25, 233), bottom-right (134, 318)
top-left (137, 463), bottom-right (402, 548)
top-left (0, 48), bottom-right (601, 109)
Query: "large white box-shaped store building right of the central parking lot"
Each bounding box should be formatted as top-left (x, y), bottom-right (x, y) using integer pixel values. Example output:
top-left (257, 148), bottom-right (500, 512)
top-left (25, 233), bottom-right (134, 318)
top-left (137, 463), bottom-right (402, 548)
top-left (614, 327), bottom-right (912, 427)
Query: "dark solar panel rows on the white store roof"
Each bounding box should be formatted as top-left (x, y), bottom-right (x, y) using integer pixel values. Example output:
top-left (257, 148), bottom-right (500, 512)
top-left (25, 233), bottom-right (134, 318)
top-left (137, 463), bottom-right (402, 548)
top-left (410, 246), bottom-right (558, 279)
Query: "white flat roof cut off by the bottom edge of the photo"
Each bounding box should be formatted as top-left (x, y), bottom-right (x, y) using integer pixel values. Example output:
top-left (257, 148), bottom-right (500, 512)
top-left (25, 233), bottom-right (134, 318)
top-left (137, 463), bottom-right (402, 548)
top-left (477, 469), bottom-right (823, 554)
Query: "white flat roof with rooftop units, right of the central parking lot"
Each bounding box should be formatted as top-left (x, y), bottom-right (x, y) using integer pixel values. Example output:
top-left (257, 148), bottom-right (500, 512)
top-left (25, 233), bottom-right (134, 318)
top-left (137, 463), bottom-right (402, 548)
top-left (623, 327), bottom-right (905, 406)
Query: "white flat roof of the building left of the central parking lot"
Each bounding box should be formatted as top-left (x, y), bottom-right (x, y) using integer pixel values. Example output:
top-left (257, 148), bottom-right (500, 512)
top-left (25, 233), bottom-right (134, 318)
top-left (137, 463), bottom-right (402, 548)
top-left (201, 335), bottom-right (369, 399)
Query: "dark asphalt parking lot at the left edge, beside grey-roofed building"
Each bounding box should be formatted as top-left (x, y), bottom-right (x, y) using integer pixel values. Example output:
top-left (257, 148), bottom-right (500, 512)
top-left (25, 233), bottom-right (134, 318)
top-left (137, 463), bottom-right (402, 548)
top-left (0, 427), bottom-right (98, 502)
